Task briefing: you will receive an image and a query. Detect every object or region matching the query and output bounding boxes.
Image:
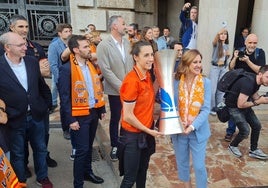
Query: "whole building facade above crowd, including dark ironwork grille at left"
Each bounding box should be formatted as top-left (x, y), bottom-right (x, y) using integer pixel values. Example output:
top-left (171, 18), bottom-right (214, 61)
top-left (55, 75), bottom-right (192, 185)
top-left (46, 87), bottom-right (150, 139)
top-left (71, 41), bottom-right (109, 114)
top-left (0, 0), bottom-right (268, 74)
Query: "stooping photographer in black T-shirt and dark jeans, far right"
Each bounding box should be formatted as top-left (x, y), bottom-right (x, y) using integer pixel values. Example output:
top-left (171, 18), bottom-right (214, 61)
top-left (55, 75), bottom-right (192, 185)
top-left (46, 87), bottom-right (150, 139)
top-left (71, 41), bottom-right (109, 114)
top-left (225, 65), bottom-right (268, 160)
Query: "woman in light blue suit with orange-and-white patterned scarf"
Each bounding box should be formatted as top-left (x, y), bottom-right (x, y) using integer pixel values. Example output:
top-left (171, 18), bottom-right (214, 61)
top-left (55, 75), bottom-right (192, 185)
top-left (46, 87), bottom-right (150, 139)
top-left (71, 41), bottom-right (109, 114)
top-left (171, 50), bottom-right (211, 188)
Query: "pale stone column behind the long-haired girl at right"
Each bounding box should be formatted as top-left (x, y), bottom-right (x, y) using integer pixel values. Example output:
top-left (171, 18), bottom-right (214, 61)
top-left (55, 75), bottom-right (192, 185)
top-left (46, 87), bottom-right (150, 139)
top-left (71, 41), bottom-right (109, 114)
top-left (197, 0), bottom-right (239, 76)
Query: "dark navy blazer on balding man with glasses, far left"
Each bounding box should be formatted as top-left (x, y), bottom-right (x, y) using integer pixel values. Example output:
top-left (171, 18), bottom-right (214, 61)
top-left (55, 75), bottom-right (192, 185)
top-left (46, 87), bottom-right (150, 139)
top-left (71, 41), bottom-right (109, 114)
top-left (0, 56), bottom-right (52, 128)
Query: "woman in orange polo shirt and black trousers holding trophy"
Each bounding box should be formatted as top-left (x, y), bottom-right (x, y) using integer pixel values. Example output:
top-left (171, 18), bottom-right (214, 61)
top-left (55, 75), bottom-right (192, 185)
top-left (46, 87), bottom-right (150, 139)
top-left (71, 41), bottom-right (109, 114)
top-left (118, 41), bottom-right (162, 188)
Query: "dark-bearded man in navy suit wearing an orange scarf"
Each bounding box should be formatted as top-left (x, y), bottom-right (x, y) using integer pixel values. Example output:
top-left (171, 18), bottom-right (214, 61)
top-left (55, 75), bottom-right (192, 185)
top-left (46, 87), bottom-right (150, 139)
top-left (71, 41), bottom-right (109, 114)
top-left (58, 35), bottom-right (106, 188)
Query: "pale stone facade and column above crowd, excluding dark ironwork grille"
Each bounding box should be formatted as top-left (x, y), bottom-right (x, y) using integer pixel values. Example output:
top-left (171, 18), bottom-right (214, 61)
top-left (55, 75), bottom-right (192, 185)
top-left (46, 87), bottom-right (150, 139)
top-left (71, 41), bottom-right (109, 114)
top-left (70, 0), bottom-right (268, 74)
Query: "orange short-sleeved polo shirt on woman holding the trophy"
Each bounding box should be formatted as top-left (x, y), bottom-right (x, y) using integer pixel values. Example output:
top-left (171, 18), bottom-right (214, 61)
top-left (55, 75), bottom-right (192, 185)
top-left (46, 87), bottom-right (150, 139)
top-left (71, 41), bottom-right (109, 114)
top-left (120, 66), bottom-right (155, 132)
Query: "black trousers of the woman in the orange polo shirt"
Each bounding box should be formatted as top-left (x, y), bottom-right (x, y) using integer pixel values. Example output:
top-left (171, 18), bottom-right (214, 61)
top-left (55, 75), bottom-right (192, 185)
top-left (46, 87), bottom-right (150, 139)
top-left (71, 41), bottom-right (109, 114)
top-left (118, 129), bottom-right (155, 188)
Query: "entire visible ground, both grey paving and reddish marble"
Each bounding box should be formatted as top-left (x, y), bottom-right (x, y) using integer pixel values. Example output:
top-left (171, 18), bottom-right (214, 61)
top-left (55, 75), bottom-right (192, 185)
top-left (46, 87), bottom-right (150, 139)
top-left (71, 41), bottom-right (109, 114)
top-left (23, 80), bottom-right (268, 188)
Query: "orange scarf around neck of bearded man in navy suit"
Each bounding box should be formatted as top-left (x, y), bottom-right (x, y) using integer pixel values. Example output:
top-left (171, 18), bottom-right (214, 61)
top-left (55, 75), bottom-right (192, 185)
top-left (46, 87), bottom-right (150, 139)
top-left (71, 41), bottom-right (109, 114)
top-left (70, 54), bottom-right (105, 116)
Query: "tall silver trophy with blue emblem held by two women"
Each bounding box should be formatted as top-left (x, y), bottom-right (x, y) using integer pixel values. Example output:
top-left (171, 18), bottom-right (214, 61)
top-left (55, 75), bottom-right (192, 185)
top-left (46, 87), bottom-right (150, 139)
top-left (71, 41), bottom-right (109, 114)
top-left (155, 49), bottom-right (183, 135)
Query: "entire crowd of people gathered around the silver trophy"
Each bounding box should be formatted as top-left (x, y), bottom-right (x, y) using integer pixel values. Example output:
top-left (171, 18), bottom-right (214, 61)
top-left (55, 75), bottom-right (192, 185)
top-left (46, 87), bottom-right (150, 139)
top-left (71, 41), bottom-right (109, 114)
top-left (0, 3), bottom-right (268, 188)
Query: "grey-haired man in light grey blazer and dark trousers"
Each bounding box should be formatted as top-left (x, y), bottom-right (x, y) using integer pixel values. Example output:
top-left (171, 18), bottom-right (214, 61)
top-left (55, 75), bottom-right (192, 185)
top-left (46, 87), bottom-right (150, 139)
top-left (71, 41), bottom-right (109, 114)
top-left (97, 15), bottom-right (134, 161)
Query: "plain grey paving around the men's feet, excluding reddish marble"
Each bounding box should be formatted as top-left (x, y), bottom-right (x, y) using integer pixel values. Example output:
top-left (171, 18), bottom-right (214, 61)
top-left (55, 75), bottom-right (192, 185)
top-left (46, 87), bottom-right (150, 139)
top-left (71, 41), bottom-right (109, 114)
top-left (27, 128), bottom-right (118, 188)
